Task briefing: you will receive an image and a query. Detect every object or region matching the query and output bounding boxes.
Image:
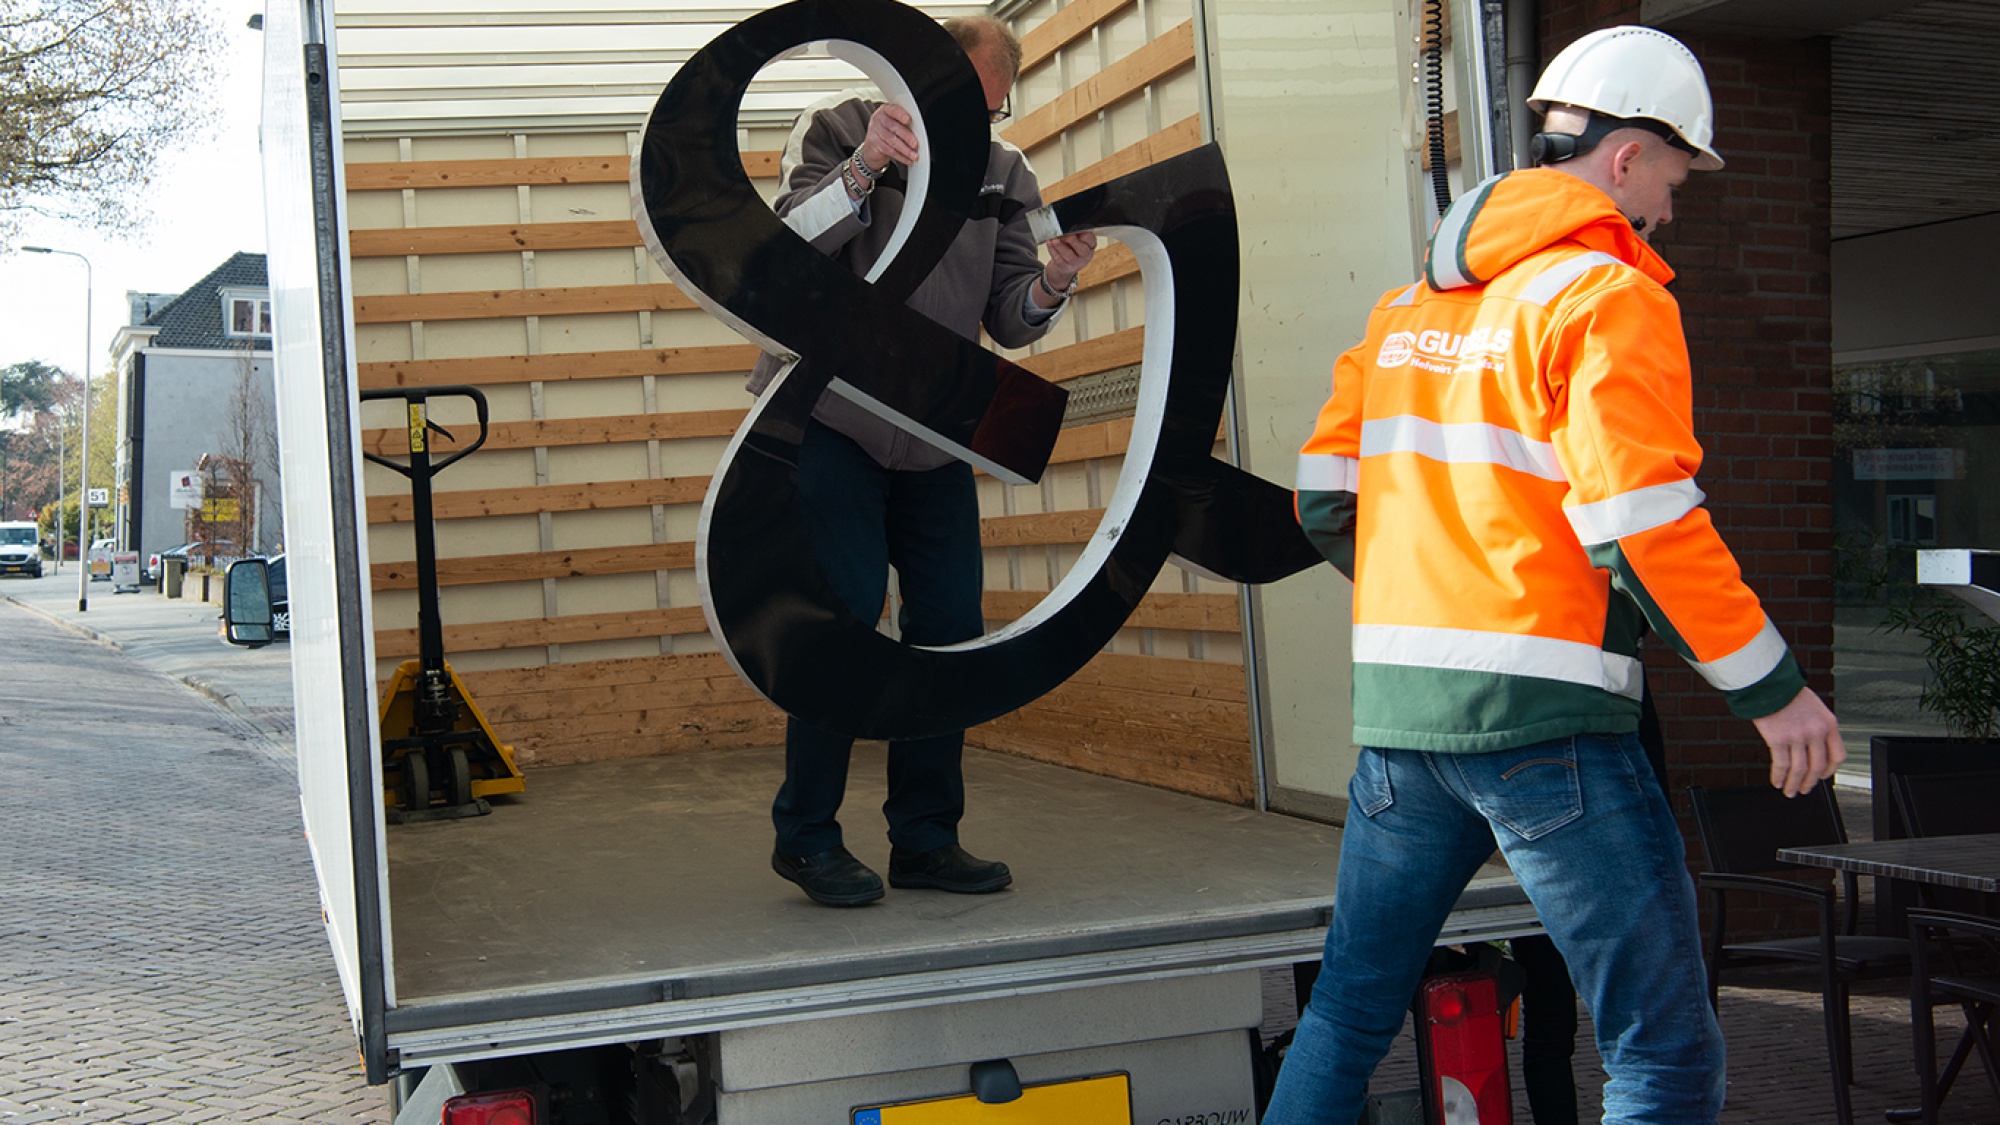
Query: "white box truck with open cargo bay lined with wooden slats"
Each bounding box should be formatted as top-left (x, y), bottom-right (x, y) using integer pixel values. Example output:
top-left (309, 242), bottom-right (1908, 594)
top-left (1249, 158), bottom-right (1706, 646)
top-left (264, 0), bottom-right (1536, 1125)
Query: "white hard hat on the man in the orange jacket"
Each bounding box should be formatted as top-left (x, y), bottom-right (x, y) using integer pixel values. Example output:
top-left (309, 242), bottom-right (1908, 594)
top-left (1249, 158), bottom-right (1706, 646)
top-left (1528, 26), bottom-right (1722, 172)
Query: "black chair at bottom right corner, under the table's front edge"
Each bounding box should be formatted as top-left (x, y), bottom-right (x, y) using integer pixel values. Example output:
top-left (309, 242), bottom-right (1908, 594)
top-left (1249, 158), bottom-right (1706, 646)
top-left (1910, 900), bottom-right (2000, 1125)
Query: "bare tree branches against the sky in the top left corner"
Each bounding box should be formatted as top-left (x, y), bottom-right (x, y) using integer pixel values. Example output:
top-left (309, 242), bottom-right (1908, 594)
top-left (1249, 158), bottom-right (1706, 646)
top-left (0, 0), bottom-right (222, 240)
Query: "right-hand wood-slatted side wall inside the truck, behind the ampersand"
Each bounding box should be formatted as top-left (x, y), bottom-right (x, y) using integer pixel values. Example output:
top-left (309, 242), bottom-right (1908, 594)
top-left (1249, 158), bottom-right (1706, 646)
top-left (968, 0), bottom-right (1254, 803)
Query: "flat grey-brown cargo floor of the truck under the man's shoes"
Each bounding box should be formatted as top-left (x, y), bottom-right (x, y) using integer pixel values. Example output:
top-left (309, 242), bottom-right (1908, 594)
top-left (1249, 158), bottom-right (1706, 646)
top-left (388, 743), bottom-right (1368, 1005)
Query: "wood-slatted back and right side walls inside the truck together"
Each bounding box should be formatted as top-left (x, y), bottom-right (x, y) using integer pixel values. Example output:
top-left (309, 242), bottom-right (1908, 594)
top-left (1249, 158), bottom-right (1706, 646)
top-left (346, 0), bottom-right (1250, 803)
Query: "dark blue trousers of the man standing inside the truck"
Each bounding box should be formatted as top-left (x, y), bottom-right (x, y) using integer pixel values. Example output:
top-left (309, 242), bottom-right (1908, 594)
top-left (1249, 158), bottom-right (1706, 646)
top-left (770, 420), bottom-right (986, 855)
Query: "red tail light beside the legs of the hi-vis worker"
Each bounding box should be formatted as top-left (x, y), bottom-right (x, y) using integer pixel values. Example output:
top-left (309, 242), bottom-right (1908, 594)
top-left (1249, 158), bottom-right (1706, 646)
top-left (1416, 973), bottom-right (1514, 1125)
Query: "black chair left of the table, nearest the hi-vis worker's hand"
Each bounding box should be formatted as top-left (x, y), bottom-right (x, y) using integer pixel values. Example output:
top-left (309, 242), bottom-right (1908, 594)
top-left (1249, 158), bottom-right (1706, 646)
top-left (1688, 785), bottom-right (1910, 1125)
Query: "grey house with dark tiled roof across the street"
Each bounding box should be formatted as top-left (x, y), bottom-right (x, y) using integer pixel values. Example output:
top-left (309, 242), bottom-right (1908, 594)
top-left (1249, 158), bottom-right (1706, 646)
top-left (112, 252), bottom-right (284, 558)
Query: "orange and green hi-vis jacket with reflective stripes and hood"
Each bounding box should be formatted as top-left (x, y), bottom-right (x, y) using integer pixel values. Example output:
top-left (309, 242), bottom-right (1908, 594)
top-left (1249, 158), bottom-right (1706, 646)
top-left (1298, 168), bottom-right (1806, 753)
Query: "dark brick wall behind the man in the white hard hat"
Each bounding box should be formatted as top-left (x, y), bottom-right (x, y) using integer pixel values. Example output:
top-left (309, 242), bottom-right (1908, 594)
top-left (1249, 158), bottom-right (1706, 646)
top-left (1542, 8), bottom-right (1834, 933)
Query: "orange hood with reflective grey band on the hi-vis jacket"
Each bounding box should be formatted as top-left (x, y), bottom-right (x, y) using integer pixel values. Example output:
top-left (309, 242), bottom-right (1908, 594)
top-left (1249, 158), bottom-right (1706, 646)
top-left (1424, 168), bottom-right (1674, 290)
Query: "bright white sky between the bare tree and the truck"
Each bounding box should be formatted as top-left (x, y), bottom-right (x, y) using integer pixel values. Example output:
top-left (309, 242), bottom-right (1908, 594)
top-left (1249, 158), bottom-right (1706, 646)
top-left (0, 0), bottom-right (264, 374)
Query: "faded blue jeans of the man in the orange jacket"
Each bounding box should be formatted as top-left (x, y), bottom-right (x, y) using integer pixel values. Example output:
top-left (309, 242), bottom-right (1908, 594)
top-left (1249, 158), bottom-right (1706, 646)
top-left (1264, 735), bottom-right (1724, 1125)
